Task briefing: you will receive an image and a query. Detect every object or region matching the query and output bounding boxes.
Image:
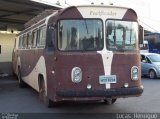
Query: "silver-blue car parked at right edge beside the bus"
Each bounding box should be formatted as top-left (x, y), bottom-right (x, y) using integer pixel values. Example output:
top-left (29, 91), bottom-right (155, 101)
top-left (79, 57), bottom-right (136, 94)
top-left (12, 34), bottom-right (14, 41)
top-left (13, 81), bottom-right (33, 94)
top-left (141, 53), bottom-right (160, 79)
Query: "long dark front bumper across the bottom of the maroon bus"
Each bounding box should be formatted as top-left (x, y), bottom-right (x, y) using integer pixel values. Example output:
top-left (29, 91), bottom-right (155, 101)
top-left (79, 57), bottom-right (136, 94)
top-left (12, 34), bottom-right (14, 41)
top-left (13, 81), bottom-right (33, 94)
top-left (56, 86), bottom-right (143, 98)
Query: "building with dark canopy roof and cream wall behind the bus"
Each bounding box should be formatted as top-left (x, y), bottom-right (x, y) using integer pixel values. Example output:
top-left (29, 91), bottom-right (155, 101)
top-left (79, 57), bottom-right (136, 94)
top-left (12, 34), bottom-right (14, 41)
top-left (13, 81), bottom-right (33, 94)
top-left (0, 0), bottom-right (61, 76)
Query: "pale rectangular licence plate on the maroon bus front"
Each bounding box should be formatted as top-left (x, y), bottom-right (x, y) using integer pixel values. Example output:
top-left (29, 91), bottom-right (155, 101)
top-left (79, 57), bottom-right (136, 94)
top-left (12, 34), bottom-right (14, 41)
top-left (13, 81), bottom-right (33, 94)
top-left (99, 75), bottom-right (117, 84)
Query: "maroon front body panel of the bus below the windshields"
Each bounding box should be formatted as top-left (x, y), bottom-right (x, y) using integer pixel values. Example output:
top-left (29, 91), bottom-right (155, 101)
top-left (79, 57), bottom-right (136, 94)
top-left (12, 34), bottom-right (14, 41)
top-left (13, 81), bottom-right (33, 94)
top-left (50, 53), bottom-right (141, 100)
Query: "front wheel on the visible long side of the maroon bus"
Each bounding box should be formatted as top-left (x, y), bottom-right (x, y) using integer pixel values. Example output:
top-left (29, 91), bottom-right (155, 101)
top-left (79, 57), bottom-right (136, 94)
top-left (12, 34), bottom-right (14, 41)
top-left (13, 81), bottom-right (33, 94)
top-left (39, 78), bottom-right (53, 108)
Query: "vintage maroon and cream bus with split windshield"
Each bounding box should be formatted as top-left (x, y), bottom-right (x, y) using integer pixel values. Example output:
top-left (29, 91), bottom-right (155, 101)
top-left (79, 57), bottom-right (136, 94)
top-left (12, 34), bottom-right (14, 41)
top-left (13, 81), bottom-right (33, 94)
top-left (13, 5), bottom-right (143, 107)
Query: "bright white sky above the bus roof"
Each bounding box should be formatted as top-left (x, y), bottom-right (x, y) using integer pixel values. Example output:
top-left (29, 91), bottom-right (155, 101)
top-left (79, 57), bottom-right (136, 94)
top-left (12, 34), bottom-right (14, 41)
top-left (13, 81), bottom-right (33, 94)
top-left (33, 0), bottom-right (160, 32)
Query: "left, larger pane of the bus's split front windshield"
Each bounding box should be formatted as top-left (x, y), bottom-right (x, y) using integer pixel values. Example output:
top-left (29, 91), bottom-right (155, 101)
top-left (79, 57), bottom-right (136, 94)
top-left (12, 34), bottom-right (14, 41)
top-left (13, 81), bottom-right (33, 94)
top-left (58, 19), bottom-right (103, 51)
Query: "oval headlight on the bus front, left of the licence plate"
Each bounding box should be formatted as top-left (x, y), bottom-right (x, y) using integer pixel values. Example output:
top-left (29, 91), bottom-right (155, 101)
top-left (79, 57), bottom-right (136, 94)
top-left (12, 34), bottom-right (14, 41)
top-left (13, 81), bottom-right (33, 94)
top-left (71, 67), bottom-right (82, 83)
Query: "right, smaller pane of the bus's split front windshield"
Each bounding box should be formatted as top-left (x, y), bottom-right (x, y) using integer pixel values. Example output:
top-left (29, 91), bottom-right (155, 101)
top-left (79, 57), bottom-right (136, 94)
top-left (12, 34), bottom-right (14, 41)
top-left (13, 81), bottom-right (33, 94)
top-left (106, 20), bottom-right (138, 51)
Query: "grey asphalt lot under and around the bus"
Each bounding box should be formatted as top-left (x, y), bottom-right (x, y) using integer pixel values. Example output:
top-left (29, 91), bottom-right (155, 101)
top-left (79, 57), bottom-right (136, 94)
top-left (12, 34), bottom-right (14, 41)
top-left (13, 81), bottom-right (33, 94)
top-left (0, 77), bottom-right (160, 118)
